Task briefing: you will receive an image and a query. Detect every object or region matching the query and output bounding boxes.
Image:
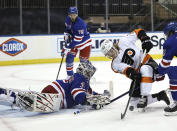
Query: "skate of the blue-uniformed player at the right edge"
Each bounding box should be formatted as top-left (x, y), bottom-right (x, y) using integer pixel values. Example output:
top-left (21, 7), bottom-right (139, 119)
top-left (164, 101), bottom-right (177, 116)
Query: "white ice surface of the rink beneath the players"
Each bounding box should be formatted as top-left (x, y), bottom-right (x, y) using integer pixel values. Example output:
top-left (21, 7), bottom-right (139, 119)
top-left (0, 60), bottom-right (177, 131)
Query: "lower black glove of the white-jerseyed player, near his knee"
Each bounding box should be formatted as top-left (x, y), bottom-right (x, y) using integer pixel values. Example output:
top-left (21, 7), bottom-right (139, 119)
top-left (126, 68), bottom-right (141, 83)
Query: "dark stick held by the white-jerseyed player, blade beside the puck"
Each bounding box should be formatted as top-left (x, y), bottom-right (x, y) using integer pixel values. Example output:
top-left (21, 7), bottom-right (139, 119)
top-left (121, 51), bottom-right (147, 119)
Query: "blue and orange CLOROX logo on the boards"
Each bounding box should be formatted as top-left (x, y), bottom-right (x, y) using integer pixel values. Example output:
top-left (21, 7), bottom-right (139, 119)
top-left (0, 38), bottom-right (27, 56)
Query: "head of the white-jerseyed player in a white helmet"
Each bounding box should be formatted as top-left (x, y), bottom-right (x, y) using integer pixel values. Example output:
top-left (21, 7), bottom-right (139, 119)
top-left (101, 40), bottom-right (118, 59)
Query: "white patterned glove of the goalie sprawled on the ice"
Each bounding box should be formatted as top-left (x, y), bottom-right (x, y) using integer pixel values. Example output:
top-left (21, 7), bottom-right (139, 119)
top-left (86, 90), bottom-right (111, 110)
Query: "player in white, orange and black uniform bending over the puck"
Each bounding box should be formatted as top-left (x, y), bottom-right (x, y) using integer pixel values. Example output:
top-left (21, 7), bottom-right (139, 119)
top-left (101, 29), bottom-right (170, 111)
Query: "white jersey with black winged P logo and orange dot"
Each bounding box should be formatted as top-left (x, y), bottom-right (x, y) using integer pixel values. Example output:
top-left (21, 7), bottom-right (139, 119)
top-left (111, 32), bottom-right (143, 74)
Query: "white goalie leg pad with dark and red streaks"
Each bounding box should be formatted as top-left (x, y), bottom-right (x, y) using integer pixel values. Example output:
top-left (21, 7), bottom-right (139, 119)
top-left (17, 92), bottom-right (63, 112)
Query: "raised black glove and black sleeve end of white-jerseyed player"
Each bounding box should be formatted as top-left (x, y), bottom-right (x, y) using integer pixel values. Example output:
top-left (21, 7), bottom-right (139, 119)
top-left (138, 30), bottom-right (153, 53)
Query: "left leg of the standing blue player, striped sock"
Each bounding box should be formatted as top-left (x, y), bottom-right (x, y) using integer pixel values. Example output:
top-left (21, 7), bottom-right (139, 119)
top-left (66, 49), bottom-right (78, 76)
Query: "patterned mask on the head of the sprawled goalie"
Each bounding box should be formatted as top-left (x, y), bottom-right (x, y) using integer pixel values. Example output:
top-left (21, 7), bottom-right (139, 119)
top-left (76, 62), bottom-right (96, 80)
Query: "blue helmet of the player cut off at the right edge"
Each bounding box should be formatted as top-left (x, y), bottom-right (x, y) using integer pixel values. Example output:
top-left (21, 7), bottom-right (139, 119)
top-left (163, 22), bottom-right (177, 36)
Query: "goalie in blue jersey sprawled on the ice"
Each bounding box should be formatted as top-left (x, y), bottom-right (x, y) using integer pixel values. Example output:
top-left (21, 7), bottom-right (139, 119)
top-left (0, 63), bottom-right (110, 112)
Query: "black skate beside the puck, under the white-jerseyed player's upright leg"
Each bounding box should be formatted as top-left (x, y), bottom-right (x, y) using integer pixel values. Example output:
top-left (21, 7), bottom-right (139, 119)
top-left (137, 96), bottom-right (148, 112)
